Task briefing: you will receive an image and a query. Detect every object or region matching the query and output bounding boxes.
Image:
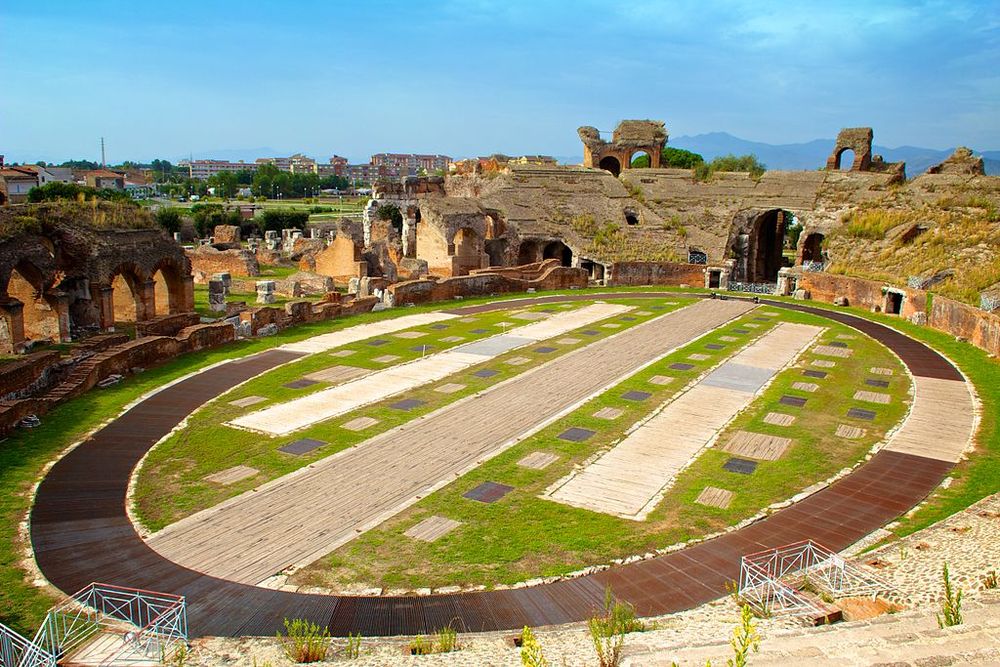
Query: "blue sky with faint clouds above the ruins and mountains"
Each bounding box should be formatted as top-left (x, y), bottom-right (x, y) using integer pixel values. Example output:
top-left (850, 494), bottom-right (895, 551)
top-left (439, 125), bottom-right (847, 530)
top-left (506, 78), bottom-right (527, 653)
top-left (0, 0), bottom-right (1000, 162)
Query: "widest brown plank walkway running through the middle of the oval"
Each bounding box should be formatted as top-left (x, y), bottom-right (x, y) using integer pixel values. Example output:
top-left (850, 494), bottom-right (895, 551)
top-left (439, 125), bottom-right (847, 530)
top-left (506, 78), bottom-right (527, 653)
top-left (149, 301), bottom-right (749, 583)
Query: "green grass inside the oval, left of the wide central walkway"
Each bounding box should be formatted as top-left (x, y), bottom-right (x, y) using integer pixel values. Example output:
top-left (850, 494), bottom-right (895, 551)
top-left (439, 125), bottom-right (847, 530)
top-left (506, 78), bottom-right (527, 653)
top-left (135, 299), bottom-right (679, 531)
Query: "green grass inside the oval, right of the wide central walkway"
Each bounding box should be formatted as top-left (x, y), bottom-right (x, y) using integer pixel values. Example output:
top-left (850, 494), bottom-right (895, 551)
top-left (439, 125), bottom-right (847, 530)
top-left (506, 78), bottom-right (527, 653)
top-left (295, 313), bottom-right (909, 589)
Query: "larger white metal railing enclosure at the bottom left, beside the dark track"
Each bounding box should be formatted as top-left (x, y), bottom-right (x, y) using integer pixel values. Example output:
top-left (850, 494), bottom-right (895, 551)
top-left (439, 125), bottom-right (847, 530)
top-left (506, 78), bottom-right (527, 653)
top-left (34, 583), bottom-right (187, 664)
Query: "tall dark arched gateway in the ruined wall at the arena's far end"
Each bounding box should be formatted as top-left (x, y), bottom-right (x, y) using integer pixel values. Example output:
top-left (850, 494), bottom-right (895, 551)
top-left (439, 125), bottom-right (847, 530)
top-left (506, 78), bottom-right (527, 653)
top-left (731, 208), bottom-right (792, 283)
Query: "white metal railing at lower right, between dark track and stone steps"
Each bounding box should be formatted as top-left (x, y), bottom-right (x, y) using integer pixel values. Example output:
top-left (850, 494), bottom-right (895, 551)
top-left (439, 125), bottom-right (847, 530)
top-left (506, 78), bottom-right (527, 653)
top-left (739, 540), bottom-right (893, 615)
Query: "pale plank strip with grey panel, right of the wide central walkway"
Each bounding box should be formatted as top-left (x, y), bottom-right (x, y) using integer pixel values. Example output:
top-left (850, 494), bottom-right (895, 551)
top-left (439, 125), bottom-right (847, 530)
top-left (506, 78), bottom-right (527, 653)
top-left (544, 323), bottom-right (823, 521)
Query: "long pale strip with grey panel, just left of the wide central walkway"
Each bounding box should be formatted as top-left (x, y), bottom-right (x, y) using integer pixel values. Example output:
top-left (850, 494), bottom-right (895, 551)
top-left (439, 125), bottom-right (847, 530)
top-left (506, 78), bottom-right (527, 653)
top-left (229, 303), bottom-right (631, 435)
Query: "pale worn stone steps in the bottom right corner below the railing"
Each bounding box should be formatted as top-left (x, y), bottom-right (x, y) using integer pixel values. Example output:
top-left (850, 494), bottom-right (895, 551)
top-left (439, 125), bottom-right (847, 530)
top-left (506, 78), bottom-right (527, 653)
top-left (623, 591), bottom-right (1000, 667)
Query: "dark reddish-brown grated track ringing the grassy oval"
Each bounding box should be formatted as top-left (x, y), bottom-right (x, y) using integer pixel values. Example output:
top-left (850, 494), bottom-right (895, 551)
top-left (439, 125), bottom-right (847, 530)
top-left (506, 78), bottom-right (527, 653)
top-left (31, 292), bottom-right (962, 636)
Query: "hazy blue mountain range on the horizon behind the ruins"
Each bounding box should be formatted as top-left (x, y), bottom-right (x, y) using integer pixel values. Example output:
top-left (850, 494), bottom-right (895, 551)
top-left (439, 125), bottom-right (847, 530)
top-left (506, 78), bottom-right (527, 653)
top-left (667, 132), bottom-right (1000, 177)
